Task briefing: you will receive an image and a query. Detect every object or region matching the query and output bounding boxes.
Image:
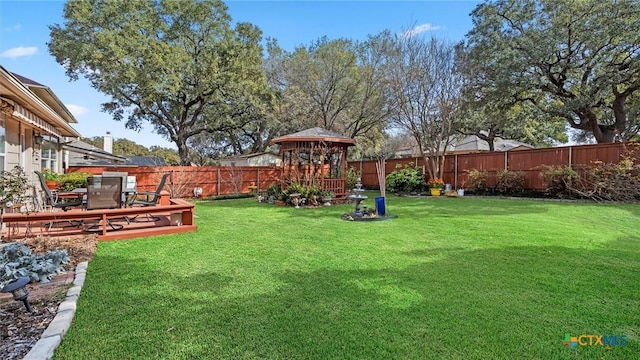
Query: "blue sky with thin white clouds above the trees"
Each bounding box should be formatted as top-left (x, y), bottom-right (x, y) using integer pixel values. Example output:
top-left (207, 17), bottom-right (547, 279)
top-left (0, 0), bottom-right (479, 148)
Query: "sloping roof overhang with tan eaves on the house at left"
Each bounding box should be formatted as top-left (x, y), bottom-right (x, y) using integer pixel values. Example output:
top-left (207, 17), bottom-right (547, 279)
top-left (0, 65), bottom-right (80, 137)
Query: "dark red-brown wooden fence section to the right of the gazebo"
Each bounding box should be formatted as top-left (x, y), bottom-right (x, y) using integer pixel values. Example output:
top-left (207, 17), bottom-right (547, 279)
top-left (348, 143), bottom-right (640, 190)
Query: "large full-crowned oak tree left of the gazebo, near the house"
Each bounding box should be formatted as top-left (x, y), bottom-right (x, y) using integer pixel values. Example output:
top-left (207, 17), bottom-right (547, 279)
top-left (48, 0), bottom-right (269, 165)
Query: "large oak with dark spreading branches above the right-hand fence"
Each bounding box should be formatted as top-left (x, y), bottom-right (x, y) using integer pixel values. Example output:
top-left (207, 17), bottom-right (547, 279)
top-left (467, 0), bottom-right (640, 142)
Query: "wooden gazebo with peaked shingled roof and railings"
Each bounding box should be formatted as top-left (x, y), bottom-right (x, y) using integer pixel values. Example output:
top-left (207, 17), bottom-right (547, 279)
top-left (273, 127), bottom-right (356, 197)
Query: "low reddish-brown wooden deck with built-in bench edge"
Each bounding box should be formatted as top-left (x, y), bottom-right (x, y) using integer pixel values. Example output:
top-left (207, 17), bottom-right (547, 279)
top-left (2, 199), bottom-right (197, 241)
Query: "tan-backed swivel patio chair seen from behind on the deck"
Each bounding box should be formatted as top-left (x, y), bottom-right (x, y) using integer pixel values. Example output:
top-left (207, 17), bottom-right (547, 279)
top-left (84, 176), bottom-right (124, 232)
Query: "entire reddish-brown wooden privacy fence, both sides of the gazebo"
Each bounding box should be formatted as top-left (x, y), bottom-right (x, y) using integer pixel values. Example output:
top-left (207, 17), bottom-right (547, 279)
top-left (67, 143), bottom-right (640, 198)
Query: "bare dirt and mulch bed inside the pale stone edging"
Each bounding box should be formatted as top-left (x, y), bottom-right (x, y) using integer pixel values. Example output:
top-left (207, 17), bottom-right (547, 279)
top-left (0, 234), bottom-right (98, 360)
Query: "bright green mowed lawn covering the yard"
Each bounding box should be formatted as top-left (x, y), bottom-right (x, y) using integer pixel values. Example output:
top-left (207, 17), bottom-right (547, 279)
top-left (55, 193), bottom-right (640, 359)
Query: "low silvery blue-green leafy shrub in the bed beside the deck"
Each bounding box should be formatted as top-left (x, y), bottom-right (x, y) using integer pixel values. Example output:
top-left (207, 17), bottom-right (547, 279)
top-left (0, 243), bottom-right (69, 287)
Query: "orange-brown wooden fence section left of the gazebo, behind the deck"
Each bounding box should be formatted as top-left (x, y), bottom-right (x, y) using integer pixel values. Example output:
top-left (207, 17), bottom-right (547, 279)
top-left (67, 166), bottom-right (282, 198)
